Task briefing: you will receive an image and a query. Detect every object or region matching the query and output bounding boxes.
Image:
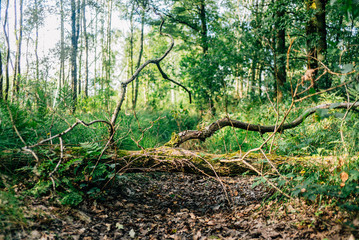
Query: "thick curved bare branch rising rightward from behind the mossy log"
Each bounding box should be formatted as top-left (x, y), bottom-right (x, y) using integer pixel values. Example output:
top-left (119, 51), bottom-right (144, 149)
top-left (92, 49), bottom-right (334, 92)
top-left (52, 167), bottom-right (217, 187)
top-left (166, 102), bottom-right (359, 147)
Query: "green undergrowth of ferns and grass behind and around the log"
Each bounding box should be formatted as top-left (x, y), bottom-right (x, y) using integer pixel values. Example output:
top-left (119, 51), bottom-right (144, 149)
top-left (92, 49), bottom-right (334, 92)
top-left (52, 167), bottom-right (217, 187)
top-left (0, 93), bottom-right (359, 227)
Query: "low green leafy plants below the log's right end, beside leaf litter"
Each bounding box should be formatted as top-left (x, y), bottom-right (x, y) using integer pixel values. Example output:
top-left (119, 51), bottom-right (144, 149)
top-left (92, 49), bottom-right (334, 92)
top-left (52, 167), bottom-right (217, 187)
top-left (273, 157), bottom-right (359, 211)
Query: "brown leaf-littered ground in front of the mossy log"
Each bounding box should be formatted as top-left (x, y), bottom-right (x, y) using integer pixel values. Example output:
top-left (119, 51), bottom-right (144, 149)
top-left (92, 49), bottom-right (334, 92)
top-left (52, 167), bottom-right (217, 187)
top-left (0, 172), bottom-right (359, 240)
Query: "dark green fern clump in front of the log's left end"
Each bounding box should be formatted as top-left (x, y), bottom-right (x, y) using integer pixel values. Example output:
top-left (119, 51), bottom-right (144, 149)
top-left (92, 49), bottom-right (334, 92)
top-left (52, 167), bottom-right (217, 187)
top-left (18, 143), bottom-right (116, 206)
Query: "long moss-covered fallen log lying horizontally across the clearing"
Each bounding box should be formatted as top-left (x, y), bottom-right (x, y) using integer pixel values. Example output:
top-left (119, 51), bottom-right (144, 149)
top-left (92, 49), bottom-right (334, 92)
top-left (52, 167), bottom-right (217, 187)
top-left (0, 146), bottom-right (346, 176)
